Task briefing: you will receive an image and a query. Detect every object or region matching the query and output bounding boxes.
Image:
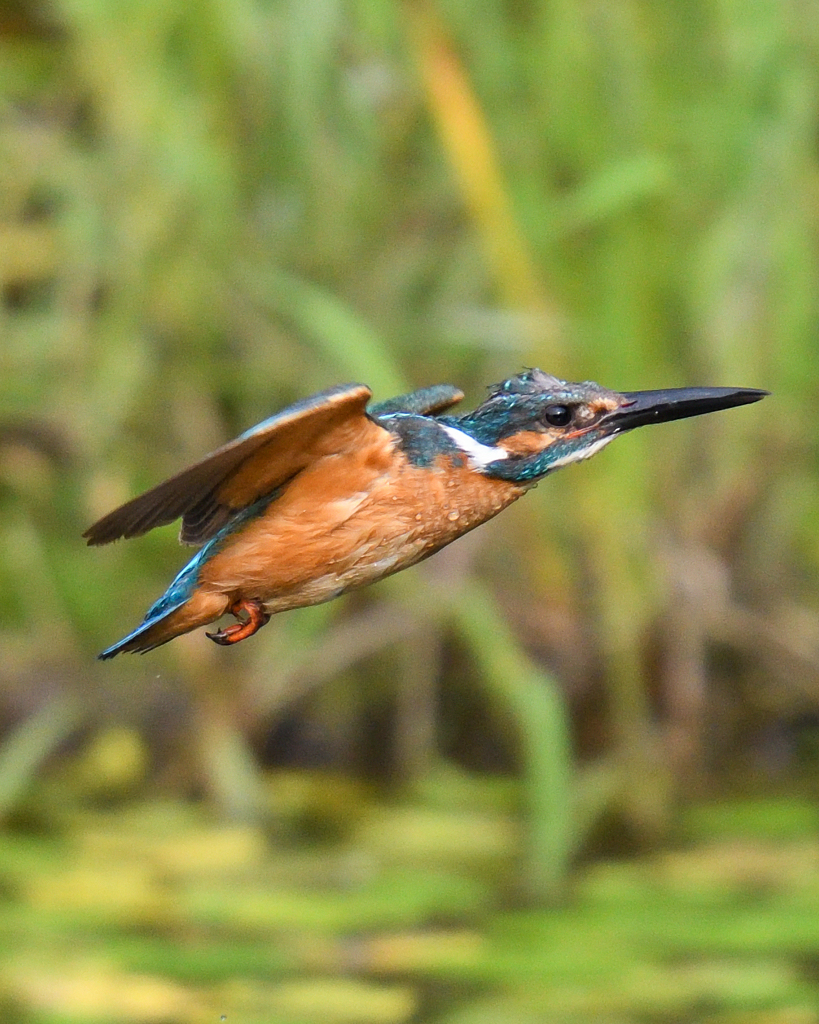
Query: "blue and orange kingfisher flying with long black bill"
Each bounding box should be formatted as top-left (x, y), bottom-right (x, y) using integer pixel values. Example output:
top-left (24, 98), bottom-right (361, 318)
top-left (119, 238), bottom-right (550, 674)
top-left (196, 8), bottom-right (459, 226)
top-left (83, 369), bottom-right (768, 659)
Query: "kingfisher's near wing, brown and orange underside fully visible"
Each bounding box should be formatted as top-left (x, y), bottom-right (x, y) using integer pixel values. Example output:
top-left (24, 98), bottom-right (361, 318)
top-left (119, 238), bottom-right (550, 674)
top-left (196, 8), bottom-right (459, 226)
top-left (83, 384), bottom-right (381, 544)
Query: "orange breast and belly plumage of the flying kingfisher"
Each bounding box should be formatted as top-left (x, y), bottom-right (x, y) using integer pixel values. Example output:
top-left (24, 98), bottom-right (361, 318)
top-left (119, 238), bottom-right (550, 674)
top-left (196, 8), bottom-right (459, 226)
top-left (200, 428), bottom-right (525, 612)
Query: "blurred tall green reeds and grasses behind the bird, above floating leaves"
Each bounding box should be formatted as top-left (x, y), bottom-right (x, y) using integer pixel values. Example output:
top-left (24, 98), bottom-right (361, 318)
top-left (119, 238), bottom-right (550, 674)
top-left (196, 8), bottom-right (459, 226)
top-left (0, 0), bottom-right (819, 893)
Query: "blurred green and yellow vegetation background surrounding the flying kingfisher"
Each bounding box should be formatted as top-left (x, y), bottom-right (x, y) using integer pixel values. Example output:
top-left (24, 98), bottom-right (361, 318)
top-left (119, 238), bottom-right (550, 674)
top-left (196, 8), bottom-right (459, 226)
top-left (0, 0), bottom-right (819, 1024)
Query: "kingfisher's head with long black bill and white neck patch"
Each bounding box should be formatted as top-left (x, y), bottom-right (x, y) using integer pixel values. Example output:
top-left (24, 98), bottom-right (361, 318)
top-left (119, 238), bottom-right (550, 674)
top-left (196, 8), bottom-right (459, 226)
top-left (441, 370), bottom-right (768, 483)
